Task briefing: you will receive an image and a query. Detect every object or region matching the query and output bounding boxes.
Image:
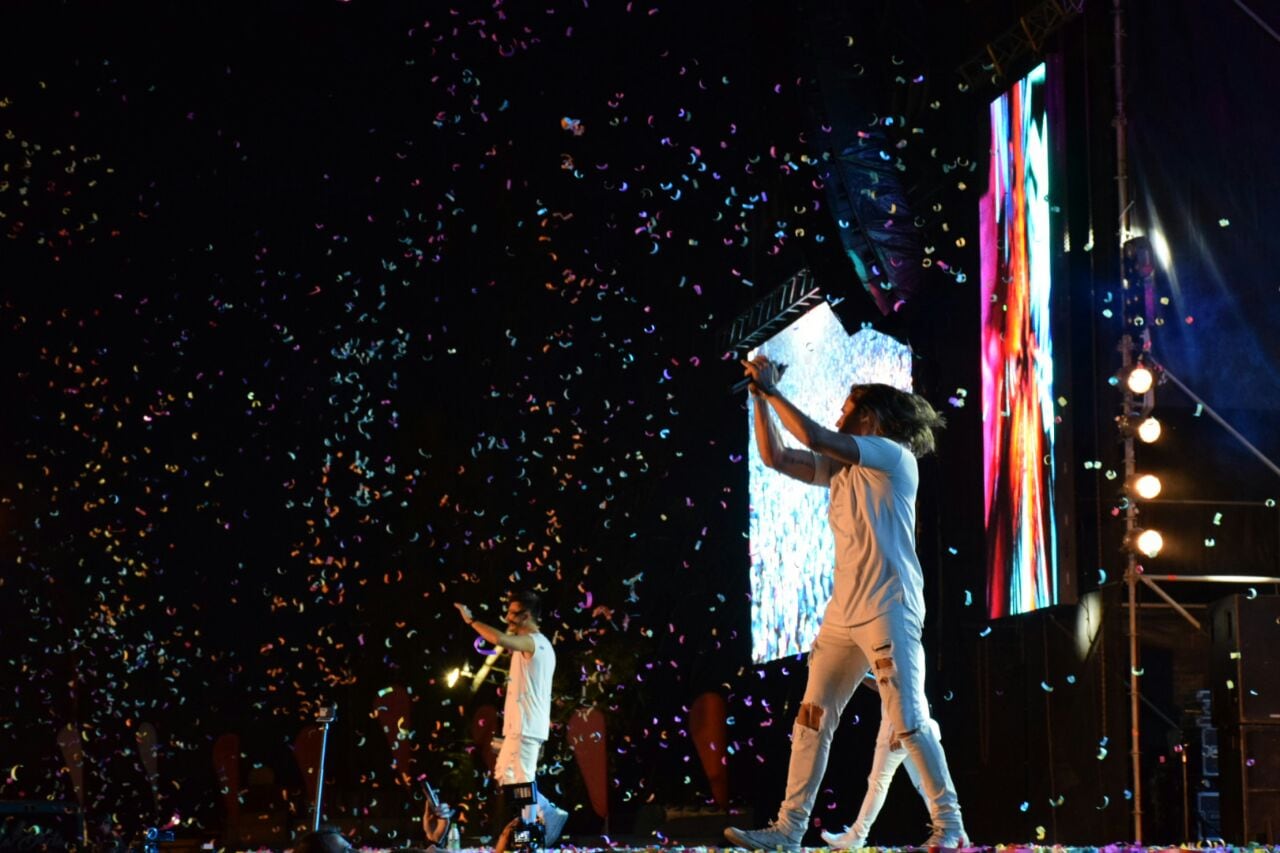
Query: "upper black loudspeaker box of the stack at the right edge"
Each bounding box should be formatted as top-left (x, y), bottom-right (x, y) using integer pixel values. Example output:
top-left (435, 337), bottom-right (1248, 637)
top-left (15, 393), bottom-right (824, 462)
top-left (1210, 596), bottom-right (1280, 727)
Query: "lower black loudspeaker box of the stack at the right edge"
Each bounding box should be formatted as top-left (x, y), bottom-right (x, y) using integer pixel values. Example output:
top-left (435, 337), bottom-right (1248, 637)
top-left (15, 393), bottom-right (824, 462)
top-left (1219, 725), bottom-right (1280, 844)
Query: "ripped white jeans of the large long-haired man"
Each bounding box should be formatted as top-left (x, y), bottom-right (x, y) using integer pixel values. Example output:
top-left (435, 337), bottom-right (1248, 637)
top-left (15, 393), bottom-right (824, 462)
top-left (778, 612), bottom-right (963, 835)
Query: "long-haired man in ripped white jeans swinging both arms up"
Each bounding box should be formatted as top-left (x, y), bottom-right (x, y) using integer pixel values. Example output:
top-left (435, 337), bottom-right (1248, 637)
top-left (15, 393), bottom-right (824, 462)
top-left (724, 356), bottom-right (968, 849)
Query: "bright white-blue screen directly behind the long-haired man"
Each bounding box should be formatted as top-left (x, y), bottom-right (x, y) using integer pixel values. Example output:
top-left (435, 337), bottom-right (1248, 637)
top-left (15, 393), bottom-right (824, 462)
top-left (746, 302), bottom-right (911, 663)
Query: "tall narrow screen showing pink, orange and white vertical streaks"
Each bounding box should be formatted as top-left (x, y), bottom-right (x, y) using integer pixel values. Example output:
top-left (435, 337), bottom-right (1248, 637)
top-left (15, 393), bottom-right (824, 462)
top-left (979, 64), bottom-right (1075, 619)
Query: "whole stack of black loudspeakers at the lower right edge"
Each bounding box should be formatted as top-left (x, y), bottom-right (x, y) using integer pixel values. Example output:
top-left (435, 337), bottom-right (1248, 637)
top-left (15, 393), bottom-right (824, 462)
top-left (1210, 596), bottom-right (1280, 844)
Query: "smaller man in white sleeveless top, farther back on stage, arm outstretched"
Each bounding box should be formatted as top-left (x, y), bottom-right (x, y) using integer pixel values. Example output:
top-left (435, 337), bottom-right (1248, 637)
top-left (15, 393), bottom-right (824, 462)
top-left (454, 590), bottom-right (568, 845)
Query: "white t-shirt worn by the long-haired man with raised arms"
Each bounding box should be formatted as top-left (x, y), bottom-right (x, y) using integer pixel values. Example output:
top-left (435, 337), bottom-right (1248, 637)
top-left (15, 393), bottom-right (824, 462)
top-left (813, 435), bottom-right (924, 628)
